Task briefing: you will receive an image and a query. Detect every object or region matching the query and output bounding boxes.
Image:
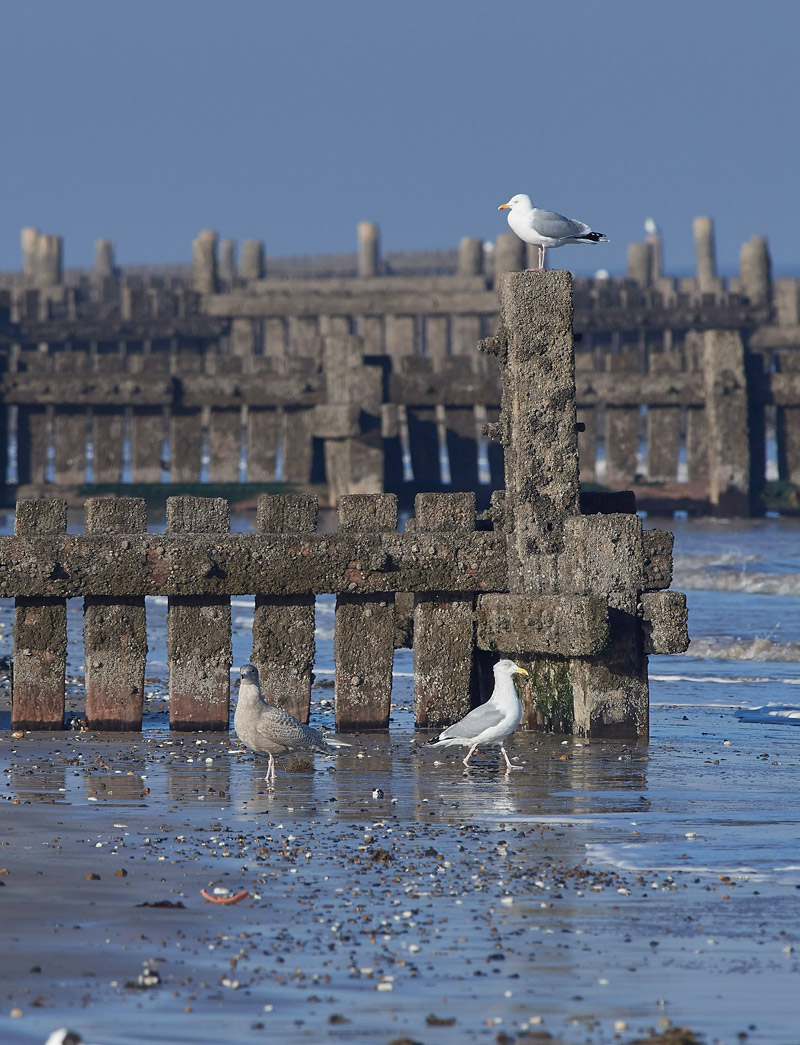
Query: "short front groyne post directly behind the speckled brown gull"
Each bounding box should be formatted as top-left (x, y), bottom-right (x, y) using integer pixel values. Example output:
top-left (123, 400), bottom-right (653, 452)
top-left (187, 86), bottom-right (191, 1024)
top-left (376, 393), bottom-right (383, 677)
top-left (252, 494), bottom-right (317, 722)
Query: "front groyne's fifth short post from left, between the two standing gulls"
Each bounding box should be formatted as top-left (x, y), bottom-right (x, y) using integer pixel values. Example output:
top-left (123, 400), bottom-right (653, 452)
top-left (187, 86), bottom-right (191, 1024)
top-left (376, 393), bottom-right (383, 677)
top-left (333, 493), bottom-right (397, 733)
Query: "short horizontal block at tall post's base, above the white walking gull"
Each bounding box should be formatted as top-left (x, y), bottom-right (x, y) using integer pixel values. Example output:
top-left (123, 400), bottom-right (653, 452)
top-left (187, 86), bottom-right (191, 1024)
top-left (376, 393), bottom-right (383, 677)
top-left (477, 595), bottom-right (608, 656)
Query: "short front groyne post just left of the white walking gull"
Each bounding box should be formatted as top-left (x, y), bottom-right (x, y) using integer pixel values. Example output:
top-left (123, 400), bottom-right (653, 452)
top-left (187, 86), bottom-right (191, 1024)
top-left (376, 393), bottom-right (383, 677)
top-left (406, 493), bottom-right (475, 728)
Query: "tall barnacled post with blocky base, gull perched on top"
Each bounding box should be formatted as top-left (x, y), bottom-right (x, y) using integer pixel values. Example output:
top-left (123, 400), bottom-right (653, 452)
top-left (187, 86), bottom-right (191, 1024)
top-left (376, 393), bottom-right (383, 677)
top-left (477, 272), bottom-right (688, 738)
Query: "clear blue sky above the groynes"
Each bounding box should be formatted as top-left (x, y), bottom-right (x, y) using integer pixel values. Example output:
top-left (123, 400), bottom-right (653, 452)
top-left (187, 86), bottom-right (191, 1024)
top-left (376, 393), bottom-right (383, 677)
top-left (0, 0), bottom-right (800, 274)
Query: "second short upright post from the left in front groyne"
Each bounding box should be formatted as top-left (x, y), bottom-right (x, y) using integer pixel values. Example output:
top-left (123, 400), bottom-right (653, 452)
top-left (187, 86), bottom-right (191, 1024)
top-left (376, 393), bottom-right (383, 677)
top-left (84, 497), bottom-right (147, 730)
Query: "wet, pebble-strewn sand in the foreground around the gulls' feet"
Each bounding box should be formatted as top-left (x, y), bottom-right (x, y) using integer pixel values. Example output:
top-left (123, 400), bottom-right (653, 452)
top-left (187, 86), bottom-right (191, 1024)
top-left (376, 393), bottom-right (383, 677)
top-left (0, 707), bottom-right (800, 1045)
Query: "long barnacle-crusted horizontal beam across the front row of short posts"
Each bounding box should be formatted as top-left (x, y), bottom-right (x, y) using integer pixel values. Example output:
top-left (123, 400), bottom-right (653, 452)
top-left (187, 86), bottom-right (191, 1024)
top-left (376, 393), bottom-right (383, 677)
top-left (0, 531), bottom-right (508, 598)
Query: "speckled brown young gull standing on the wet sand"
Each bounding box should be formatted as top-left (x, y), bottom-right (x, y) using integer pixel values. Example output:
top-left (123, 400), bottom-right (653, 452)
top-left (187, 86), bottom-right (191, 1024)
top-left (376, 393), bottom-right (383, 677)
top-left (233, 664), bottom-right (350, 784)
